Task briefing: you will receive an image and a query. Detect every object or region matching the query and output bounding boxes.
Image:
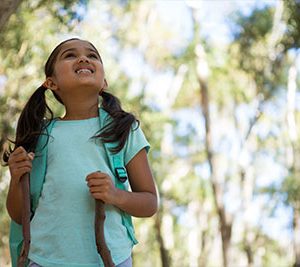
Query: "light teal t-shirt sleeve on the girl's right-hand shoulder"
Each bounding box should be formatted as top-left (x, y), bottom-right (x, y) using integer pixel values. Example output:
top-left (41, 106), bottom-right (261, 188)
top-left (124, 124), bottom-right (150, 166)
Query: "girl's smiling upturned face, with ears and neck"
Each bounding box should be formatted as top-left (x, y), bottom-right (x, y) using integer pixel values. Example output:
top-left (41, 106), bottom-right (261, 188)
top-left (42, 40), bottom-right (107, 119)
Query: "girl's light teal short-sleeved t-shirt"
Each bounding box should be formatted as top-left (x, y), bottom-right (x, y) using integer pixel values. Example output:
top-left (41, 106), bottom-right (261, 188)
top-left (29, 117), bottom-right (149, 267)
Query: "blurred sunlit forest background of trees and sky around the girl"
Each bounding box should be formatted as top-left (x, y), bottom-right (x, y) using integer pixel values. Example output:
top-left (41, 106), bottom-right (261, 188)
top-left (0, 0), bottom-right (300, 267)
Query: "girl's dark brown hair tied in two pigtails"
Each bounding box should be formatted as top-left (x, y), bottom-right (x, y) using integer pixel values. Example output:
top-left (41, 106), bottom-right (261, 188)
top-left (3, 38), bottom-right (139, 163)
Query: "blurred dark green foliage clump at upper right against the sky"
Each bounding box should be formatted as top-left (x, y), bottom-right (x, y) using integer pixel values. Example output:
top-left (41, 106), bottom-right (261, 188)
top-left (232, 7), bottom-right (286, 98)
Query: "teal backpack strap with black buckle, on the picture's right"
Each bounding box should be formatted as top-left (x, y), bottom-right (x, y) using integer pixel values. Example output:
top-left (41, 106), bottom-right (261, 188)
top-left (99, 108), bottom-right (138, 244)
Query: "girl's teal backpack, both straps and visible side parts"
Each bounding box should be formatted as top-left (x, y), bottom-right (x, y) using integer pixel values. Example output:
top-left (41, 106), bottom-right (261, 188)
top-left (9, 108), bottom-right (138, 267)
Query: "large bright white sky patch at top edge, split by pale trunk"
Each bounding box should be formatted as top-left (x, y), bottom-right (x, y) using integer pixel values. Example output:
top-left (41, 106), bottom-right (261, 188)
top-left (156, 0), bottom-right (278, 43)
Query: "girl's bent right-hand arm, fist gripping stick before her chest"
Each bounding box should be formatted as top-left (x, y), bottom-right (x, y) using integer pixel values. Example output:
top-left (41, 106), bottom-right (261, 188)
top-left (87, 149), bottom-right (158, 217)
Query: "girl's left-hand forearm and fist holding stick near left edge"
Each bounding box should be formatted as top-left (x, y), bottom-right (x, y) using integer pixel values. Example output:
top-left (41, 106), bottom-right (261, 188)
top-left (6, 147), bottom-right (34, 224)
